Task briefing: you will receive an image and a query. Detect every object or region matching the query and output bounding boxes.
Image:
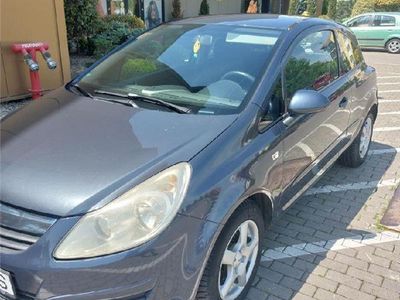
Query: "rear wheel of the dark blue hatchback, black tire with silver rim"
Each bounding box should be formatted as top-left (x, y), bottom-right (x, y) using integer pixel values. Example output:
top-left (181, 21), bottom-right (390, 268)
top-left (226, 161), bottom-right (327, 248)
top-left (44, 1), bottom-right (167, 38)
top-left (339, 113), bottom-right (375, 168)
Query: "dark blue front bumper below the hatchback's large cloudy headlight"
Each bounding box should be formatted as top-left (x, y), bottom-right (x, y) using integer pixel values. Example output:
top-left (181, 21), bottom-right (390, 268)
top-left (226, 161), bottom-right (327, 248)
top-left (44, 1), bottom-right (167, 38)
top-left (0, 215), bottom-right (219, 300)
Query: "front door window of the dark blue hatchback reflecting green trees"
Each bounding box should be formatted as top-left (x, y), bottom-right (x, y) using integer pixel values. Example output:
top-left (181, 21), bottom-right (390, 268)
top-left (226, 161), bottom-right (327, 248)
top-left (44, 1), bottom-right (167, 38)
top-left (285, 30), bottom-right (339, 99)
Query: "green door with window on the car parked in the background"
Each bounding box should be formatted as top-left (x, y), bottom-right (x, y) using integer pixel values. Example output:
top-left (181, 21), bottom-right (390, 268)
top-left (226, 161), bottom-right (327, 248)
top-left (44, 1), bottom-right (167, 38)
top-left (365, 14), bottom-right (396, 47)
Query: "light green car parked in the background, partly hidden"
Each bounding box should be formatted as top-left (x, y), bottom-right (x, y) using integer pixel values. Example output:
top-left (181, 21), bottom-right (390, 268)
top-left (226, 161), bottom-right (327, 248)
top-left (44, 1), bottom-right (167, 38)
top-left (344, 12), bottom-right (400, 53)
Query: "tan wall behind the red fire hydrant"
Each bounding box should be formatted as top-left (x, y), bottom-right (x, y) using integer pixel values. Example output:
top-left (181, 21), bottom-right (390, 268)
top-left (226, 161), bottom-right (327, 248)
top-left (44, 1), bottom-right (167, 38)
top-left (0, 0), bottom-right (71, 101)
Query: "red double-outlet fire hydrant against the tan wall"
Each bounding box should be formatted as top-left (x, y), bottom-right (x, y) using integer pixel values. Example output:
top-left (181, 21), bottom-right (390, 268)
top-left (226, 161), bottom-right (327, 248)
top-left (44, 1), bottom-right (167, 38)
top-left (11, 43), bottom-right (57, 99)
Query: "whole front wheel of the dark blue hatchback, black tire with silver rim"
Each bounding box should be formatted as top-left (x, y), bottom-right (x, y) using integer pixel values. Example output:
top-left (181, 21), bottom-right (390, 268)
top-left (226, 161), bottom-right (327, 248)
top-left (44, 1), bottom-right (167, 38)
top-left (196, 202), bottom-right (265, 300)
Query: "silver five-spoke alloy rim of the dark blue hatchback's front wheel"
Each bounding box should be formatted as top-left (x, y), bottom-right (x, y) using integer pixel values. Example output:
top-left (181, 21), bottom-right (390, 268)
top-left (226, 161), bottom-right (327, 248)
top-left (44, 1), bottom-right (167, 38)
top-left (218, 220), bottom-right (259, 300)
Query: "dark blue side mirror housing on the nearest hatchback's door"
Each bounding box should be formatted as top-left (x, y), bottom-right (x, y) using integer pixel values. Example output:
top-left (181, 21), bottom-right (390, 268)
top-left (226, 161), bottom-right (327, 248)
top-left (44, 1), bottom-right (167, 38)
top-left (288, 90), bottom-right (330, 115)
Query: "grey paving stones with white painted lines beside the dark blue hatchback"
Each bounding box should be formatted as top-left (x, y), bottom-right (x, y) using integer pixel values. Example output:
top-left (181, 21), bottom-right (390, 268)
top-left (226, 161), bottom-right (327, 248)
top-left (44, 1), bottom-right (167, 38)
top-left (247, 51), bottom-right (400, 300)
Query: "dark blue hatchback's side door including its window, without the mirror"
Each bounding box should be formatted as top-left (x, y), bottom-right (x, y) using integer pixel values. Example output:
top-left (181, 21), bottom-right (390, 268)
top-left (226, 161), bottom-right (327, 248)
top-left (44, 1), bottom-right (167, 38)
top-left (281, 30), bottom-right (350, 209)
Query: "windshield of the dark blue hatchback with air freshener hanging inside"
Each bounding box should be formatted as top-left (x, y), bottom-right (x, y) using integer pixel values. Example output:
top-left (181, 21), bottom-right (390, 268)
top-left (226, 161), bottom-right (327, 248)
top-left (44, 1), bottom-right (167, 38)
top-left (78, 24), bottom-right (281, 114)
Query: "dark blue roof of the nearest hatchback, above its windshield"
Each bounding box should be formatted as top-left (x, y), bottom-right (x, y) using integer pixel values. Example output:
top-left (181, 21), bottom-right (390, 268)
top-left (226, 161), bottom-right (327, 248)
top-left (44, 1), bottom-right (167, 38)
top-left (171, 14), bottom-right (335, 30)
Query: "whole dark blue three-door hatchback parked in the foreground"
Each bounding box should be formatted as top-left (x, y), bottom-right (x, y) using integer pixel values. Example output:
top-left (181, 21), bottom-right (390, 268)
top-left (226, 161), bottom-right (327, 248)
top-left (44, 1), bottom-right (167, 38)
top-left (0, 15), bottom-right (378, 300)
